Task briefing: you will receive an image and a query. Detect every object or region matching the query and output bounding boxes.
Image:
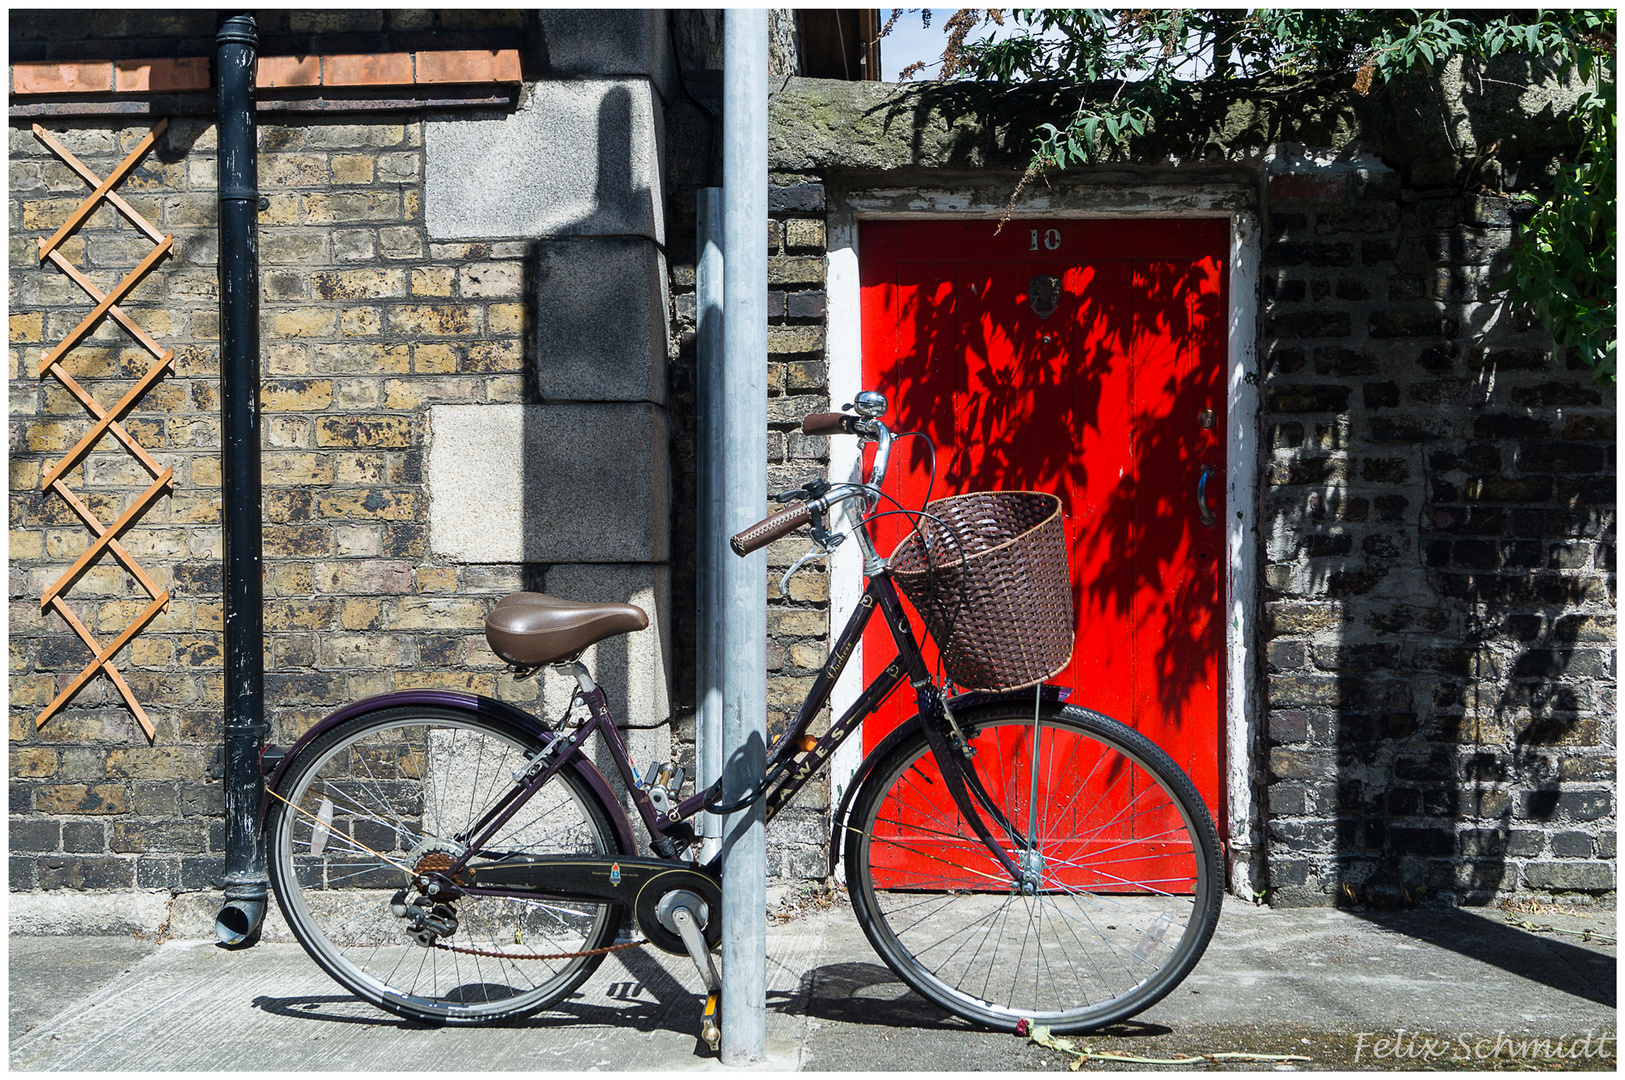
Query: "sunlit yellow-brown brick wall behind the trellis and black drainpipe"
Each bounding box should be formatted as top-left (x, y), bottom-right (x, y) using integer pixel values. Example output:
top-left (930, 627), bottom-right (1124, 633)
top-left (10, 107), bottom-right (535, 888)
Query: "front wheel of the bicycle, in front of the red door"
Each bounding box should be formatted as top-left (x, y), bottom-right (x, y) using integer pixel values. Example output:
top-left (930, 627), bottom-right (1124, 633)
top-left (845, 700), bottom-right (1224, 1033)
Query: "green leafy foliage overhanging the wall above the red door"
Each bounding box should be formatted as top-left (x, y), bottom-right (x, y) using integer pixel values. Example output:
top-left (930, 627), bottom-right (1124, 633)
top-left (892, 8), bottom-right (1617, 382)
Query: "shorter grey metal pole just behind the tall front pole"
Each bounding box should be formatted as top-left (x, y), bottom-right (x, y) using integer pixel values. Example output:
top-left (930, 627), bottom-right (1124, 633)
top-left (694, 187), bottom-right (733, 862)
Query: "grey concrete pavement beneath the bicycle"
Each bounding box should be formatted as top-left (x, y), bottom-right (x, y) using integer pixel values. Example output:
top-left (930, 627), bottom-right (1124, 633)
top-left (8, 901), bottom-right (1617, 1072)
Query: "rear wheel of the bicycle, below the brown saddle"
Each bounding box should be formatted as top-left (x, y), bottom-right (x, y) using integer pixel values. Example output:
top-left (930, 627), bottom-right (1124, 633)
top-left (267, 706), bottom-right (624, 1025)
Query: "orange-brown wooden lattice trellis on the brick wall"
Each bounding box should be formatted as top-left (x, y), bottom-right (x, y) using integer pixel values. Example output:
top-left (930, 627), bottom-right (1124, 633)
top-left (34, 120), bottom-right (176, 739)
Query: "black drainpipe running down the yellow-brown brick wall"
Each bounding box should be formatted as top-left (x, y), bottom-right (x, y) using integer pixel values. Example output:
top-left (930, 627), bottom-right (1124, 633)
top-left (215, 15), bottom-right (268, 947)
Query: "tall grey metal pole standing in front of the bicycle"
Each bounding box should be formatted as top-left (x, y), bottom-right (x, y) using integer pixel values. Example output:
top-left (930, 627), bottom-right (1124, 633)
top-left (720, 8), bottom-right (767, 1065)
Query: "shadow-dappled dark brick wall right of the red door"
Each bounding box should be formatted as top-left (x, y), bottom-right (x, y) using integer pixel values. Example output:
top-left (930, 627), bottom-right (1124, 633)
top-left (1263, 149), bottom-right (1617, 903)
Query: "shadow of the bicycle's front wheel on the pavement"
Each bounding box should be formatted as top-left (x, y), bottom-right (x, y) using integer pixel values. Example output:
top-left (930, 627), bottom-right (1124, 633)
top-left (780, 961), bottom-right (1173, 1038)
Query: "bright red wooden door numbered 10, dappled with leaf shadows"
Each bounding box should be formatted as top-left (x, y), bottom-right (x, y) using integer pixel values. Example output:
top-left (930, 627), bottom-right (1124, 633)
top-left (860, 219), bottom-right (1230, 822)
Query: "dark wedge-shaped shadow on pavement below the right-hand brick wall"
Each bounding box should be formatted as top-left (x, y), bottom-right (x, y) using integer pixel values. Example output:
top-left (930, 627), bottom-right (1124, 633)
top-left (1352, 908), bottom-right (1619, 1009)
